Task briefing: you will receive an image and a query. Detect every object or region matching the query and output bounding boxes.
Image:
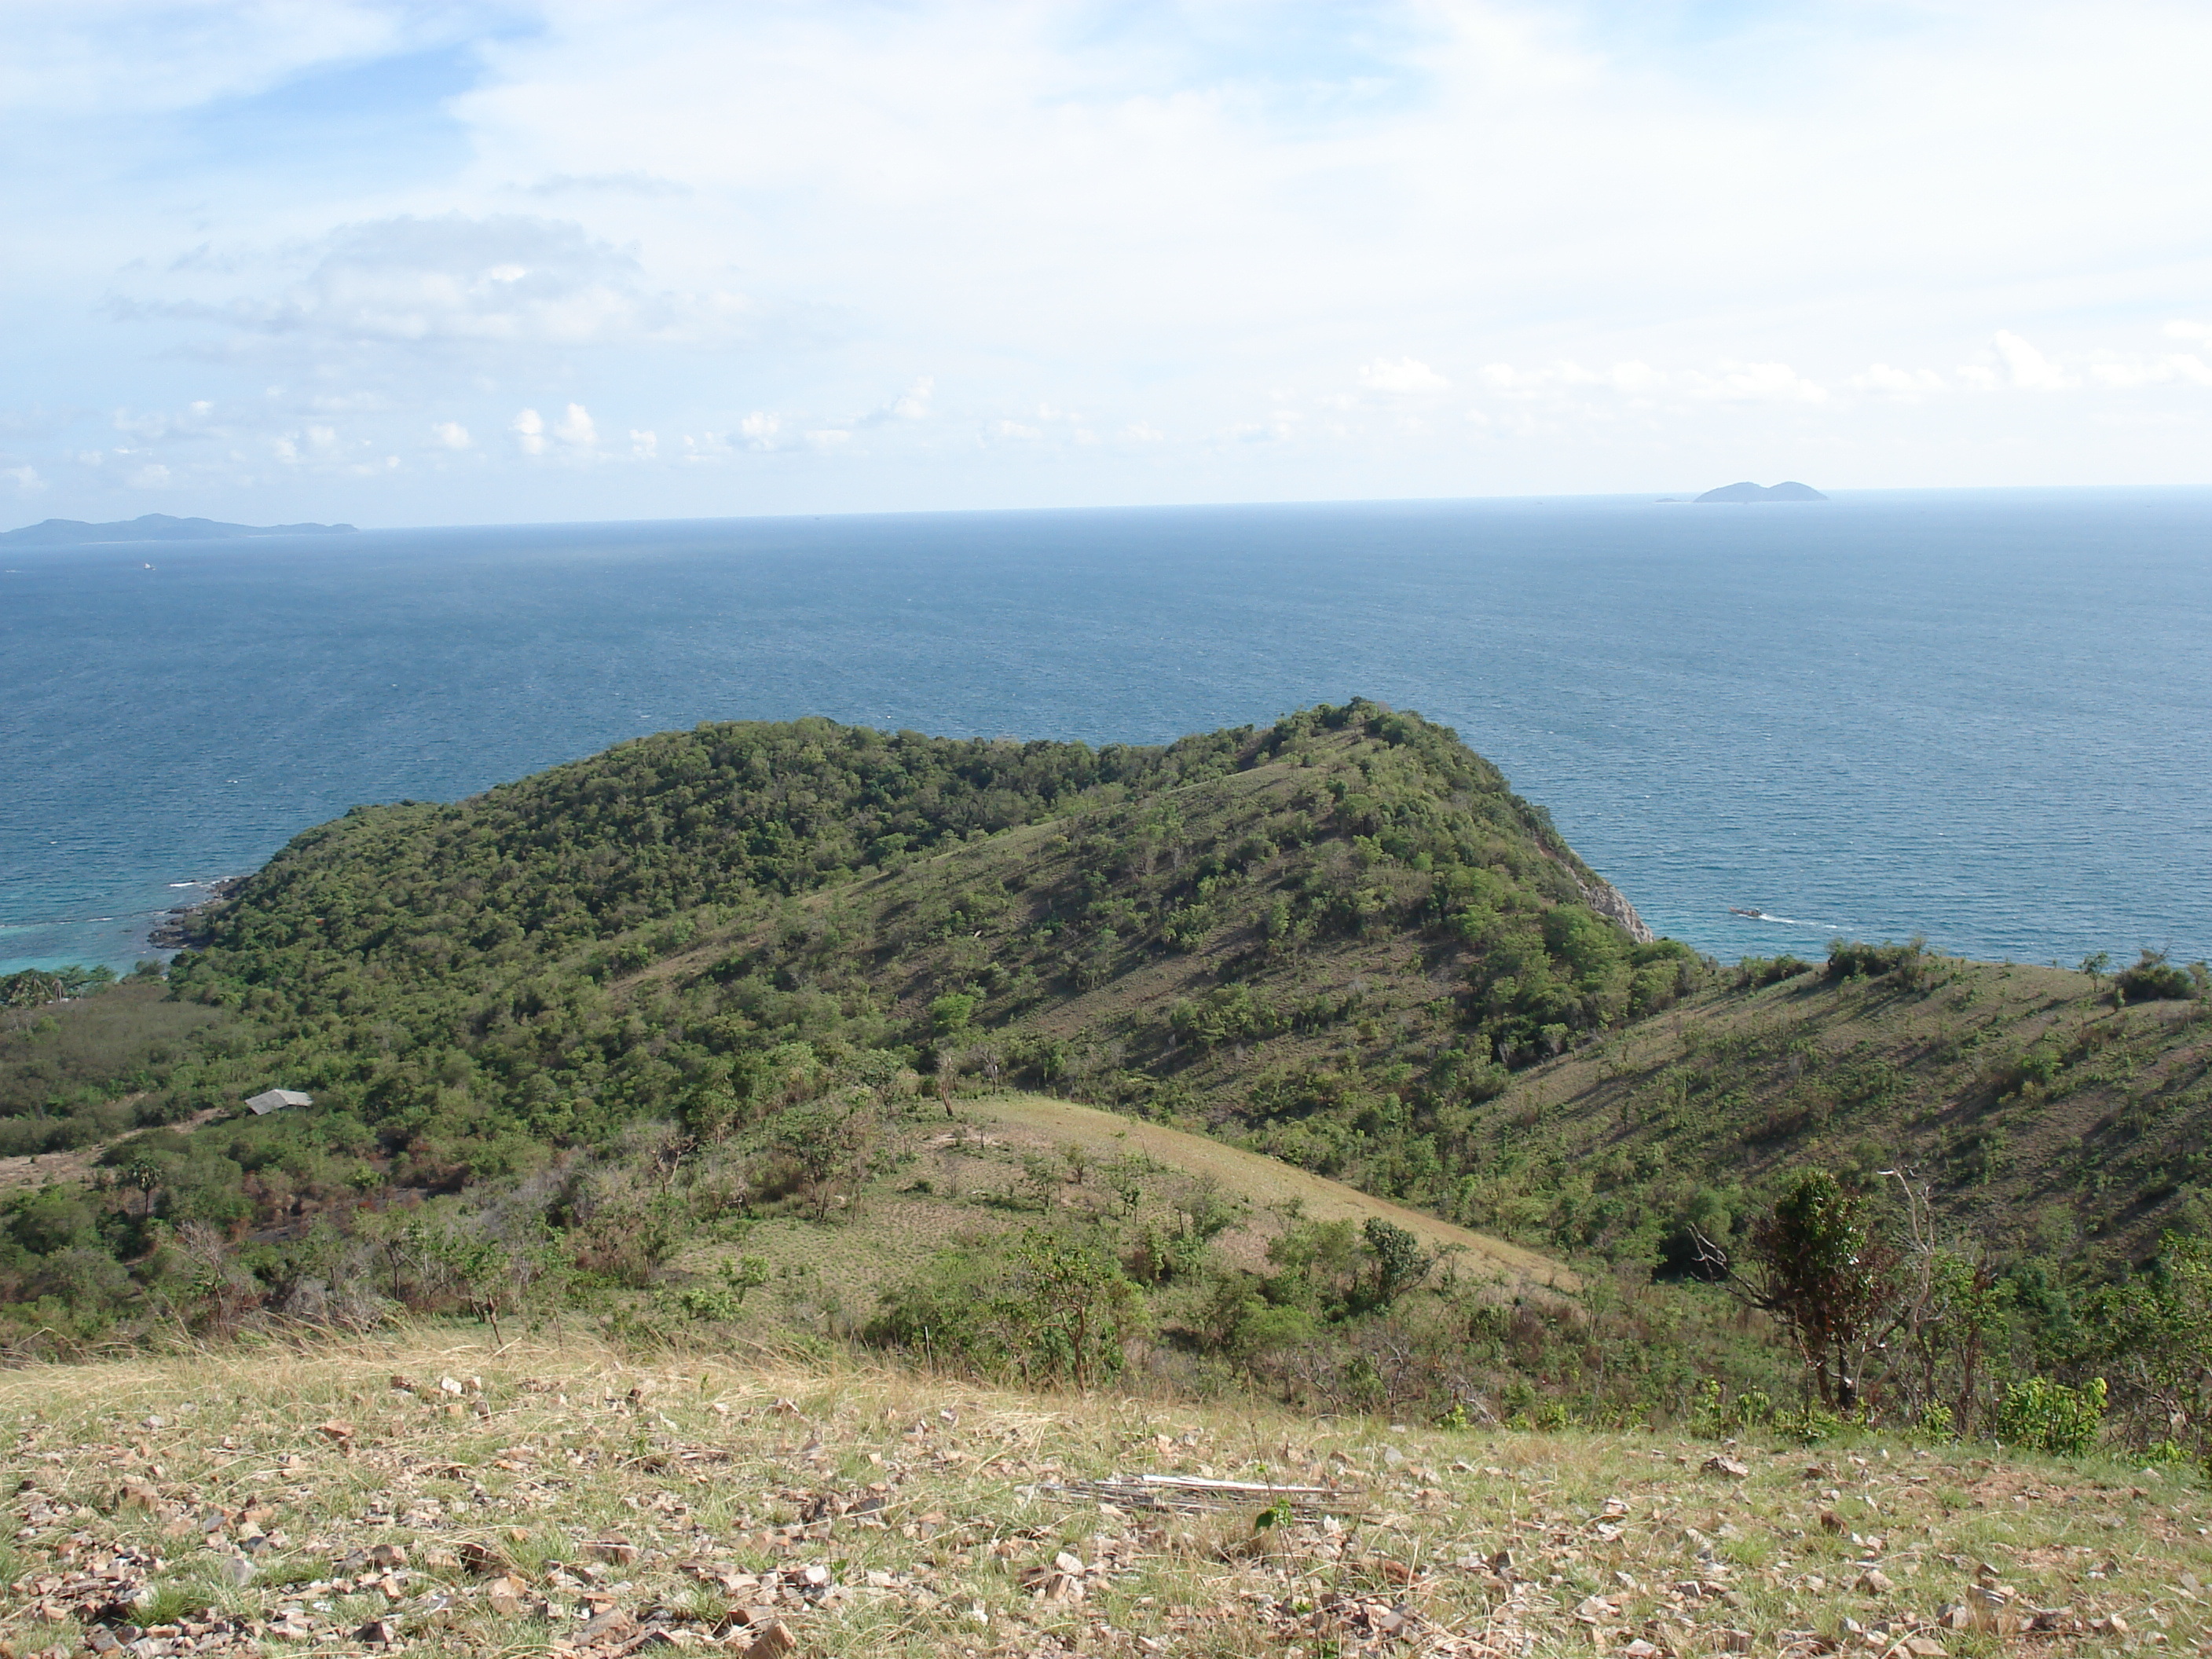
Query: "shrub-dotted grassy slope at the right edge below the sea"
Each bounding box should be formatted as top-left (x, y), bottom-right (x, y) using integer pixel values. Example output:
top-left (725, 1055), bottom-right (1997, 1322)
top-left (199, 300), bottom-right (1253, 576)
top-left (1462, 958), bottom-right (2212, 1258)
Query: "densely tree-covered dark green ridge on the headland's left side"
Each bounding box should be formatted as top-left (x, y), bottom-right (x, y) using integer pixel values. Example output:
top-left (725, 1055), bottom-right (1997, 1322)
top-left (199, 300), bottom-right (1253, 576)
top-left (201, 719), bottom-right (1241, 978)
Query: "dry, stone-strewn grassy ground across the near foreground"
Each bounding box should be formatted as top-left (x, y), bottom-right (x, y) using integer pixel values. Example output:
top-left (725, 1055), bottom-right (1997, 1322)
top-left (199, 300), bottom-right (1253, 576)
top-left (0, 1329), bottom-right (2212, 1659)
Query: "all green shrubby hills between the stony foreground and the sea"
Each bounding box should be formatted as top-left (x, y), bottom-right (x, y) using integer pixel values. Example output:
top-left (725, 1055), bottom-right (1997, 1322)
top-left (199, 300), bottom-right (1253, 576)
top-left (0, 701), bottom-right (2212, 1460)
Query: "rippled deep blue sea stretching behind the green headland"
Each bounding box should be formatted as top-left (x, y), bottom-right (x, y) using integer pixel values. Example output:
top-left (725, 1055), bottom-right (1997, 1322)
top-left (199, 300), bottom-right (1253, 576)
top-left (0, 491), bottom-right (2212, 971)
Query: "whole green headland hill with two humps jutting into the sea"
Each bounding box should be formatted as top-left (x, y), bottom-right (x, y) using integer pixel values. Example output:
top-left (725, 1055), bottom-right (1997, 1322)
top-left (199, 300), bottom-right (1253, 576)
top-left (173, 703), bottom-right (1694, 1159)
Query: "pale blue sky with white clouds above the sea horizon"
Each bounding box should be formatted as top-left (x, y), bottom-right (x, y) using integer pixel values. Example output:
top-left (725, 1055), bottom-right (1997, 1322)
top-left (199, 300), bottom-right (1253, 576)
top-left (0, 0), bottom-right (2212, 526)
